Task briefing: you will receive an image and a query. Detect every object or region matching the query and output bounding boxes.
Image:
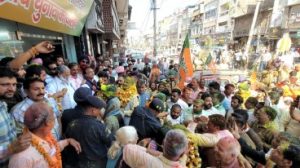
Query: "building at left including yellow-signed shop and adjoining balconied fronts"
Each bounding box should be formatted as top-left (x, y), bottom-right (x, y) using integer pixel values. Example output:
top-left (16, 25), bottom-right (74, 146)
top-left (0, 0), bottom-right (130, 62)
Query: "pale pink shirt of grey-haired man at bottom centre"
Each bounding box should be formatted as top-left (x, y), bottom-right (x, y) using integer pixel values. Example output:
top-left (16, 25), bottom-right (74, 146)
top-left (123, 144), bottom-right (185, 168)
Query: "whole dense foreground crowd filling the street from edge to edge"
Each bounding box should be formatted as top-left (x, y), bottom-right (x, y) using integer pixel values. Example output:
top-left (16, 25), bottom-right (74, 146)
top-left (0, 41), bottom-right (300, 168)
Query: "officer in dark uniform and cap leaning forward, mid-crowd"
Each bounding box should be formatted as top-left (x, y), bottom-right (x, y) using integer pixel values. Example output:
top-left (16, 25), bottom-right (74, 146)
top-left (129, 98), bottom-right (168, 144)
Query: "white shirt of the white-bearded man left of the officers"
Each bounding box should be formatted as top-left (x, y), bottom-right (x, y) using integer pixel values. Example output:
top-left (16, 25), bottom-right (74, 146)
top-left (46, 77), bottom-right (76, 110)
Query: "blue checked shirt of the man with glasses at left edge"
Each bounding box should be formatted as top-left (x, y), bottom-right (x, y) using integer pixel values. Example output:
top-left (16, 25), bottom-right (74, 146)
top-left (0, 101), bottom-right (17, 164)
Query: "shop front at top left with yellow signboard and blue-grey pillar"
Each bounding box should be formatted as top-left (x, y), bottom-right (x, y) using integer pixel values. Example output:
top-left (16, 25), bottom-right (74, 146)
top-left (0, 0), bottom-right (93, 61)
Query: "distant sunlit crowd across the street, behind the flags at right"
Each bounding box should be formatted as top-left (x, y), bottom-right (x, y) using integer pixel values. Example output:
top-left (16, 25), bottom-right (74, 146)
top-left (202, 47), bottom-right (300, 71)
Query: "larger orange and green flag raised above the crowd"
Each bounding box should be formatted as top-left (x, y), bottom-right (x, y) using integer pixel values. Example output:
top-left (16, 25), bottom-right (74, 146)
top-left (178, 35), bottom-right (194, 89)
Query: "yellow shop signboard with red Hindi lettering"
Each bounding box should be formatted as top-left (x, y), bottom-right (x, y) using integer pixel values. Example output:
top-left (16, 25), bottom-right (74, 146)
top-left (0, 0), bottom-right (93, 36)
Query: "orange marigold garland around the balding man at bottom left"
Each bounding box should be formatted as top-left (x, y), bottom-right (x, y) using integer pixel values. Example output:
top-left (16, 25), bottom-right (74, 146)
top-left (31, 134), bottom-right (62, 168)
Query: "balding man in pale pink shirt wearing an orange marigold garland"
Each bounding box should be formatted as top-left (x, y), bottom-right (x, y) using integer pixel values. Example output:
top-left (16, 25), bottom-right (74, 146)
top-left (9, 103), bottom-right (81, 168)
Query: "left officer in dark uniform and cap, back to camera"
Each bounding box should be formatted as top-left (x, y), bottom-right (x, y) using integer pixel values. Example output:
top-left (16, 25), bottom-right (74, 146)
top-left (65, 96), bottom-right (114, 168)
